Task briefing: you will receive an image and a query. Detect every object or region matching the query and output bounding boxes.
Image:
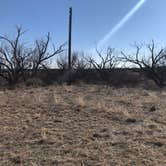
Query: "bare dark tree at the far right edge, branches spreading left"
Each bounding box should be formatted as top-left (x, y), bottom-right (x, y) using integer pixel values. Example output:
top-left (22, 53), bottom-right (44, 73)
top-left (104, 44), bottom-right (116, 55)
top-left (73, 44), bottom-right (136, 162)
top-left (120, 40), bottom-right (166, 87)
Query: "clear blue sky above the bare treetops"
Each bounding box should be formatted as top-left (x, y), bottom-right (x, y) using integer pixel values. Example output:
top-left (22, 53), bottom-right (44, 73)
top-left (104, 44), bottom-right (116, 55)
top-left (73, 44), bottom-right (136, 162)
top-left (0, 0), bottom-right (166, 51)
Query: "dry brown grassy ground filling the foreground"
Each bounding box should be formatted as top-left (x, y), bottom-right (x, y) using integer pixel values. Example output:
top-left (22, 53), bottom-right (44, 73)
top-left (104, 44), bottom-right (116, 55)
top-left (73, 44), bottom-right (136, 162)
top-left (0, 84), bottom-right (166, 166)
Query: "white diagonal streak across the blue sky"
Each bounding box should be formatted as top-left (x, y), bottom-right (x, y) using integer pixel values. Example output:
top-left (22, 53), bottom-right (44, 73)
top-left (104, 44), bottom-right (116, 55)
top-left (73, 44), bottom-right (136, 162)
top-left (97, 0), bottom-right (147, 48)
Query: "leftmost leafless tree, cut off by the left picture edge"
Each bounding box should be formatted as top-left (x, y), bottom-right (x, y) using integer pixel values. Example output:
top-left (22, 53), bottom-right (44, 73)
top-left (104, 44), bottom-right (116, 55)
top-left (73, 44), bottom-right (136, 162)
top-left (0, 27), bottom-right (29, 84)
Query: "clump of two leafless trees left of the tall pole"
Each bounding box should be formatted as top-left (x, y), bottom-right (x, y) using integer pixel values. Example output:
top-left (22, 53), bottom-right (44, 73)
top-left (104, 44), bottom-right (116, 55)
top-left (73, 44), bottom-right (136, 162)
top-left (0, 27), bottom-right (63, 84)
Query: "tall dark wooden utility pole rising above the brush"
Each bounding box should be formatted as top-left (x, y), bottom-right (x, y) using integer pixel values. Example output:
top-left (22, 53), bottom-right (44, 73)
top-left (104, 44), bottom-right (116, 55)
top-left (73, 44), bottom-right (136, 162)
top-left (68, 7), bottom-right (72, 70)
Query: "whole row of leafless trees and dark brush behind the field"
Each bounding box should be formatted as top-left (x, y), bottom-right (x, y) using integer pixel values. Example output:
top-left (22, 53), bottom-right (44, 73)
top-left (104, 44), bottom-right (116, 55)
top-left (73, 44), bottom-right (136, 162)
top-left (0, 27), bottom-right (166, 88)
